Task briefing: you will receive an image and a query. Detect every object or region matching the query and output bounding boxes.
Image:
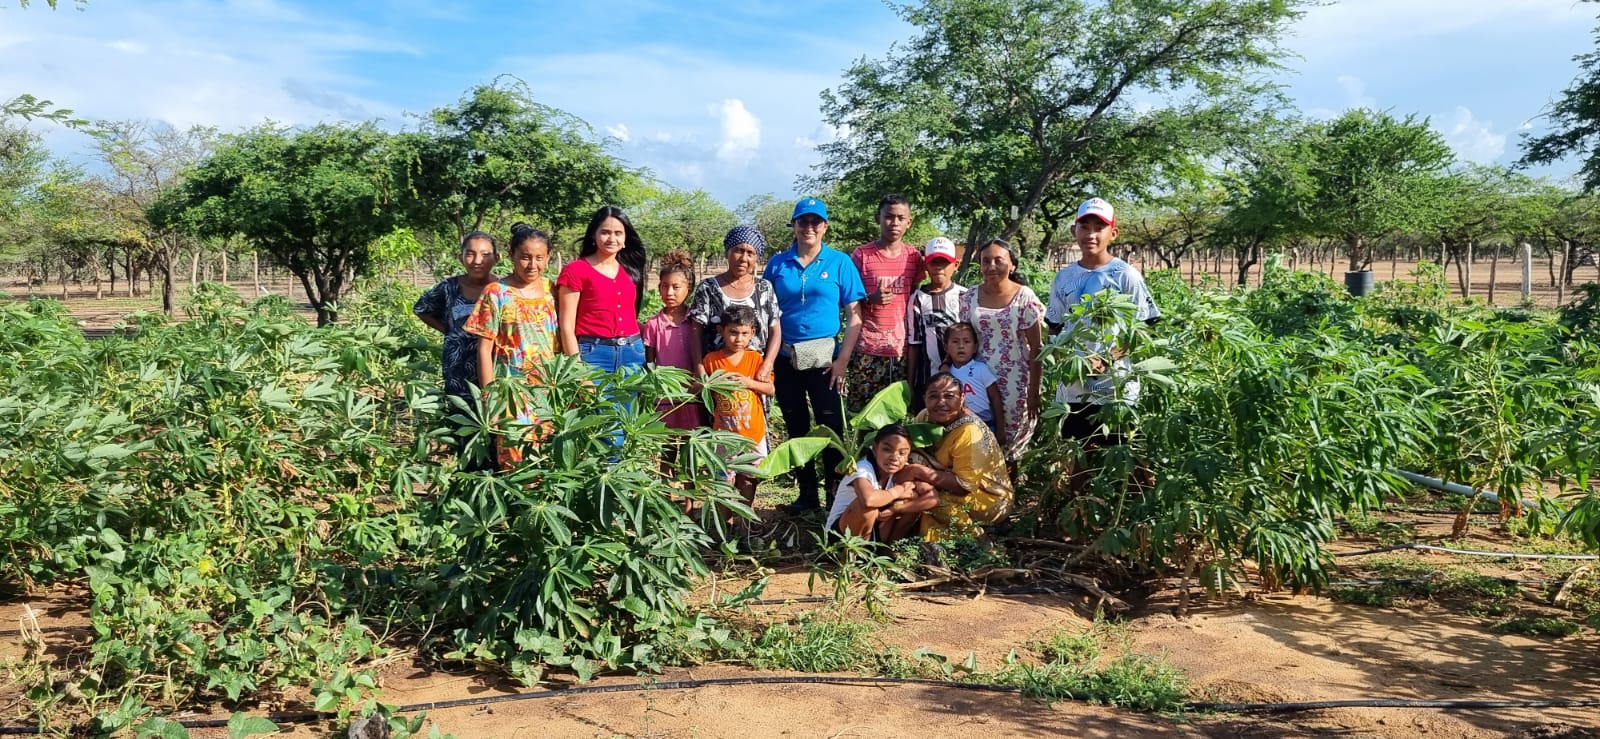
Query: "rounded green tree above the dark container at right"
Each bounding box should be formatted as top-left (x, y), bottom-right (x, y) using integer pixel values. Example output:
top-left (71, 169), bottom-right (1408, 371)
top-left (1293, 109), bottom-right (1454, 272)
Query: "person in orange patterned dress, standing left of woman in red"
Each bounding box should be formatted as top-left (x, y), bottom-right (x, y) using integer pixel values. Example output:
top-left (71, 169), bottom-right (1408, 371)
top-left (466, 222), bottom-right (555, 470)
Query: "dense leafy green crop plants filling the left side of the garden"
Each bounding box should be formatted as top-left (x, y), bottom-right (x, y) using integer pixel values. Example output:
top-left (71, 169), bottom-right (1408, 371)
top-left (0, 286), bottom-right (754, 723)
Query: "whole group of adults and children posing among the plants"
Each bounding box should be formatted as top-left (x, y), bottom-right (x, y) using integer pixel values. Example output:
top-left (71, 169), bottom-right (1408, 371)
top-left (414, 195), bottom-right (1160, 541)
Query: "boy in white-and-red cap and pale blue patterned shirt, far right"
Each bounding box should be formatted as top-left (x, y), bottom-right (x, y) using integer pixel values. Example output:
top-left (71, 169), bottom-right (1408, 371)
top-left (1045, 198), bottom-right (1162, 448)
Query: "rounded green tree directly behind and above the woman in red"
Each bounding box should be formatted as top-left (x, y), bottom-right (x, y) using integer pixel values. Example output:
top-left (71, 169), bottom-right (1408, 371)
top-left (394, 82), bottom-right (626, 243)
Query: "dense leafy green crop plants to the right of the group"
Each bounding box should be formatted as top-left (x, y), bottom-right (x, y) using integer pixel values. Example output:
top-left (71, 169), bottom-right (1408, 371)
top-left (1024, 266), bottom-right (1600, 589)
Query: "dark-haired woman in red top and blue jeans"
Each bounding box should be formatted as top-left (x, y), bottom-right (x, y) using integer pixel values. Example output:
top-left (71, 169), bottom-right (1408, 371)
top-left (555, 205), bottom-right (645, 373)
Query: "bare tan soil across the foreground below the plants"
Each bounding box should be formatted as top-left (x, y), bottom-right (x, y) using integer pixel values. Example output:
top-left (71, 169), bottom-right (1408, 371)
top-left (0, 525), bottom-right (1600, 739)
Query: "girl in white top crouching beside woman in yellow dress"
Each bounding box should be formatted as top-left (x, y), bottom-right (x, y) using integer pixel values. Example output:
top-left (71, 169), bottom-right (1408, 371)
top-left (827, 424), bottom-right (939, 542)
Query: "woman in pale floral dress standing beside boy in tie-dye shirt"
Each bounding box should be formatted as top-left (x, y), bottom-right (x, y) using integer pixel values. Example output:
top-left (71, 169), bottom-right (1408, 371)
top-left (962, 238), bottom-right (1045, 462)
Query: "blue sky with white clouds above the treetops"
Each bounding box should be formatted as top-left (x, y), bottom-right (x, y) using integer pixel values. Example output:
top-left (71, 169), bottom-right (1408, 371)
top-left (0, 0), bottom-right (1595, 206)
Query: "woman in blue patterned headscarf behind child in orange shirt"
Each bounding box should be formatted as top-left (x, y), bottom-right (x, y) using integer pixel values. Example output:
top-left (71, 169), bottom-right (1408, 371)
top-left (690, 226), bottom-right (784, 381)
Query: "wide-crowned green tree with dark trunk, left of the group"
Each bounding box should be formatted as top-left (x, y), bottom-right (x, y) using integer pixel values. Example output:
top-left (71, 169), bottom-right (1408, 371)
top-left (150, 123), bottom-right (400, 325)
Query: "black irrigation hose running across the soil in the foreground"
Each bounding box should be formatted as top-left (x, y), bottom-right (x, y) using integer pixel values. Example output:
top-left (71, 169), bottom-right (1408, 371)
top-left (0, 675), bottom-right (1600, 736)
